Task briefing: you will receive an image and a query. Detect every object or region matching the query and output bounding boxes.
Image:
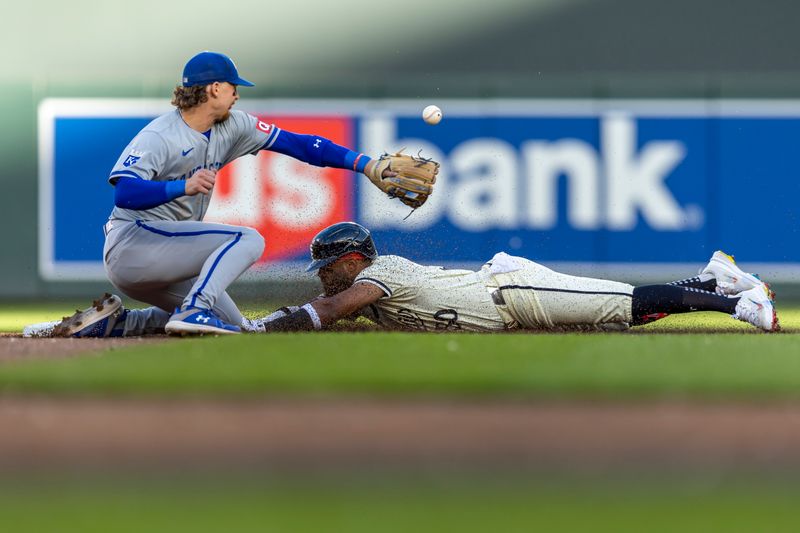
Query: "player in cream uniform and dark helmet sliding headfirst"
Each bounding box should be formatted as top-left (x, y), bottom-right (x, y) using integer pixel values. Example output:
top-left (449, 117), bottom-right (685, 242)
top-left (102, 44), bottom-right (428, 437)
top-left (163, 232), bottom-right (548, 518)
top-left (259, 222), bottom-right (779, 332)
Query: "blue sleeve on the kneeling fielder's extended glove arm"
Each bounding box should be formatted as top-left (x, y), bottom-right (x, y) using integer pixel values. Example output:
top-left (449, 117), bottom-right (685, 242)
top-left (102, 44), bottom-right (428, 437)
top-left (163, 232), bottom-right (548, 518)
top-left (268, 130), bottom-right (370, 172)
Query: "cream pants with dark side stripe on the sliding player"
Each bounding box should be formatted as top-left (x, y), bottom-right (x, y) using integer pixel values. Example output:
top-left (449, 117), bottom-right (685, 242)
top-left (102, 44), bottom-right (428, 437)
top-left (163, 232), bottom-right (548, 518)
top-left (488, 252), bottom-right (633, 329)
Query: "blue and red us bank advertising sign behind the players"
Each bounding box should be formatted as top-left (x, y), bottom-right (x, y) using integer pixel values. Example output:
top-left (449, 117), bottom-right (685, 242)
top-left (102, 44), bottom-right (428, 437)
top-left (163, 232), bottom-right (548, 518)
top-left (39, 99), bottom-right (800, 280)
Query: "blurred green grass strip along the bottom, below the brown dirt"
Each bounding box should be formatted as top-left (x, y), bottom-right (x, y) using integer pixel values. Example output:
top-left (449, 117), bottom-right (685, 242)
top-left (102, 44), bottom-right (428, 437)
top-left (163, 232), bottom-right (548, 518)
top-left (0, 479), bottom-right (800, 533)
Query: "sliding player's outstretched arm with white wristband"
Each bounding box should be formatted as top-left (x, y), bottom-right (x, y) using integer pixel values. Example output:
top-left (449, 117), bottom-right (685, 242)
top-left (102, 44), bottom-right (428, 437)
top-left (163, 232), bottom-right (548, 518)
top-left (265, 283), bottom-right (385, 333)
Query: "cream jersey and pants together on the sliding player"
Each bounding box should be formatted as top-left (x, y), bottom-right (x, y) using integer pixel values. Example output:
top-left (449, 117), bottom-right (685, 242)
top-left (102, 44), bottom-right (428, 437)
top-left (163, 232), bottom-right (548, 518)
top-left (355, 252), bottom-right (633, 331)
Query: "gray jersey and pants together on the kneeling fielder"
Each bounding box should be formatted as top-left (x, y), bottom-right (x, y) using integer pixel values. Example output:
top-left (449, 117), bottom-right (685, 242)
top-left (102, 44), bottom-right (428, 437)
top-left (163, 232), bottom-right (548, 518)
top-left (103, 110), bottom-right (280, 328)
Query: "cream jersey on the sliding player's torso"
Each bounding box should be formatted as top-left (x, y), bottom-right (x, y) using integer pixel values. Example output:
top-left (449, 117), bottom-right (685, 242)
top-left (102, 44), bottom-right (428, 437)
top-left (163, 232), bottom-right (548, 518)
top-left (355, 255), bottom-right (506, 331)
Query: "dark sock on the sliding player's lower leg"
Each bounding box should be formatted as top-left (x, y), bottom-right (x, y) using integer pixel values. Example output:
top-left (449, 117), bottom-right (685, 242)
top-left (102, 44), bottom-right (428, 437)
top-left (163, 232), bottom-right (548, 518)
top-left (632, 284), bottom-right (739, 325)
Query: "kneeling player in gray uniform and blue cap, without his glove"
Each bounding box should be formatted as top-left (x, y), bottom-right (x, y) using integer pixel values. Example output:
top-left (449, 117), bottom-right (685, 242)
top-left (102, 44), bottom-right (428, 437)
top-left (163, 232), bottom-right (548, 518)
top-left (42, 52), bottom-right (424, 337)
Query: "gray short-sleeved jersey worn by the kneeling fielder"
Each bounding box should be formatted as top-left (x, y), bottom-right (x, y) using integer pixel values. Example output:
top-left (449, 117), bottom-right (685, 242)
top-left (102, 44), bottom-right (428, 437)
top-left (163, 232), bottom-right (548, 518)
top-left (108, 109), bottom-right (280, 221)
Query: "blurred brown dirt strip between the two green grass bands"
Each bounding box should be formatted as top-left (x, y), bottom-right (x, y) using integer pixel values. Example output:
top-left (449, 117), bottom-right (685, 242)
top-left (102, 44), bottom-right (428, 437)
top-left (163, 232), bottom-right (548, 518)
top-left (0, 397), bottom-right (800, 473)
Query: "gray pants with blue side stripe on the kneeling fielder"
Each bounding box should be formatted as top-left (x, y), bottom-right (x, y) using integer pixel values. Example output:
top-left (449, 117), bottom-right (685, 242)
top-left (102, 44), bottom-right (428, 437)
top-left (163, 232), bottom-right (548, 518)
top-left (103, 220), bottom-right (264, 336)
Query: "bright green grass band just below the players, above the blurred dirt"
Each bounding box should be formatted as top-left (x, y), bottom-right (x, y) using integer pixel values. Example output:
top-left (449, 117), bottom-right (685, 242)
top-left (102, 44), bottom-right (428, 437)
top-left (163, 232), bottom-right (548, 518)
top-left (0, 300), bottom-right (800, 399)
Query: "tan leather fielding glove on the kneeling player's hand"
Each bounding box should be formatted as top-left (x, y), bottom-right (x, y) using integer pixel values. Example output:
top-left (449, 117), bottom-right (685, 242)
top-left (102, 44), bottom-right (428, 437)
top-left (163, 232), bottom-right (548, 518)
top-left (364, 152), bottom-right (439, 209)
